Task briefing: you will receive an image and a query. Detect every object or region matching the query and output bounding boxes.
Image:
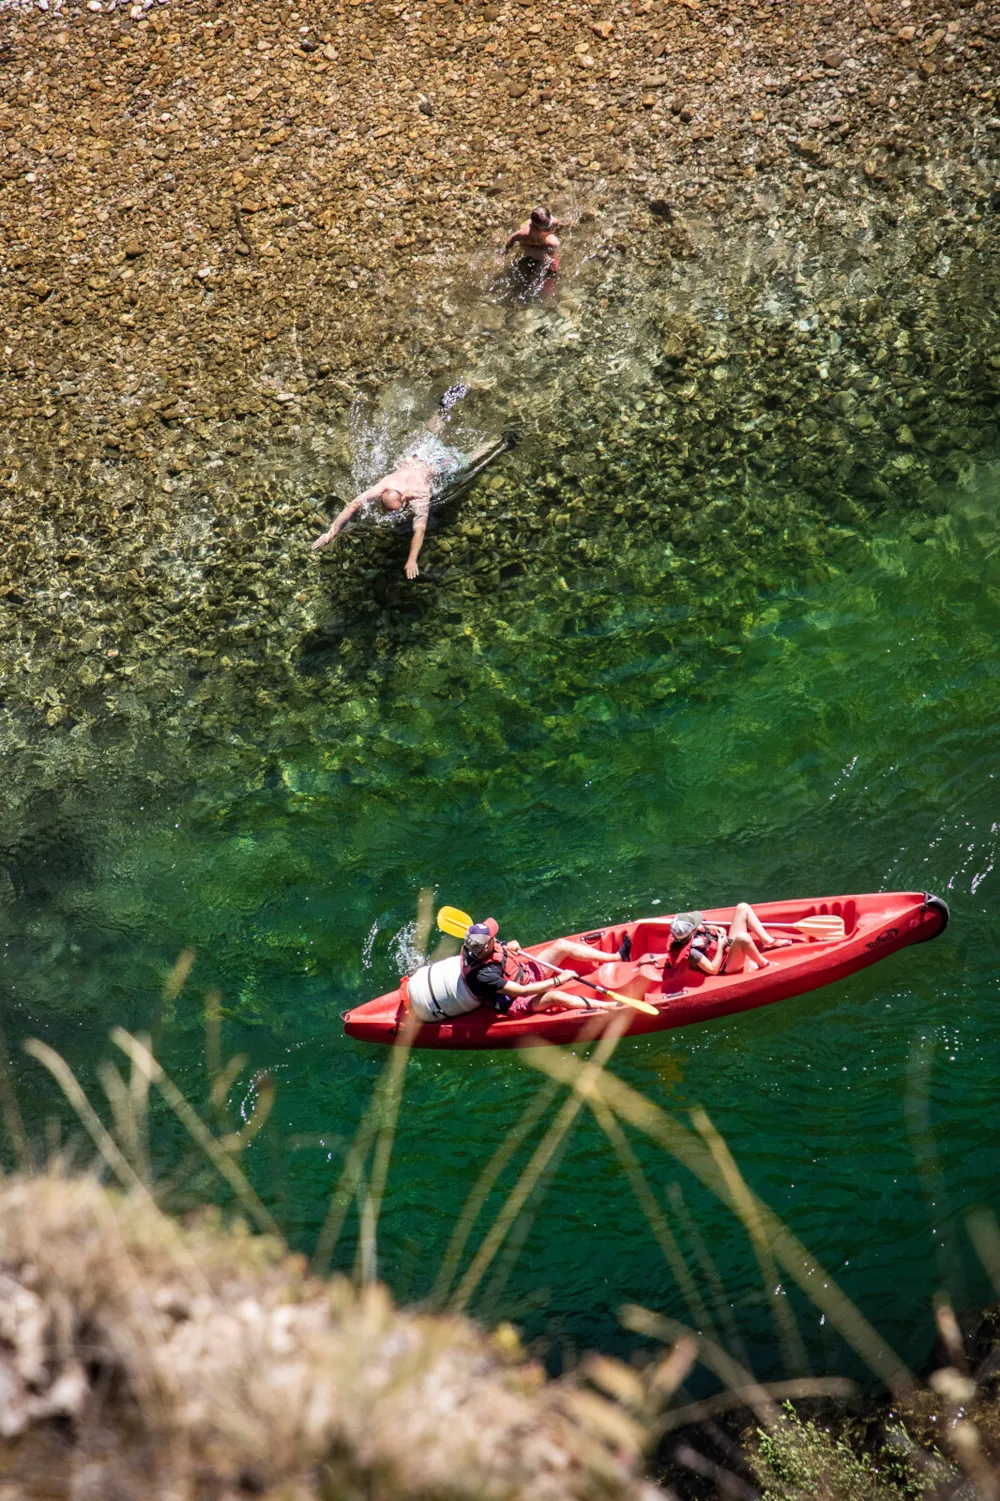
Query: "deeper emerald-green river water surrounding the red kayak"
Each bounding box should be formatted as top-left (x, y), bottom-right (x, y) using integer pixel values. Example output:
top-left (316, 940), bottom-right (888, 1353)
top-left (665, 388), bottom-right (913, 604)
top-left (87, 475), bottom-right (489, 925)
top-left (0, 456), bottom-right (1000, 1373)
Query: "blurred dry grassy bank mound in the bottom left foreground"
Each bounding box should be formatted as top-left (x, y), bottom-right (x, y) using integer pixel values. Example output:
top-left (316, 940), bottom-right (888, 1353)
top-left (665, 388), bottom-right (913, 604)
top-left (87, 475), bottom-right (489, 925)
top-left (0, 1174), bottom-right (668, 1501)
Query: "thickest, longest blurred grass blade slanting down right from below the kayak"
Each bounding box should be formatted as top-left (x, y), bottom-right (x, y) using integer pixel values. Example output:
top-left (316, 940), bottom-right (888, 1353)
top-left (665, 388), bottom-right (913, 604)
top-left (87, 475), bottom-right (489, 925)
top-left (526, 1048), bottom-right (913, 1391)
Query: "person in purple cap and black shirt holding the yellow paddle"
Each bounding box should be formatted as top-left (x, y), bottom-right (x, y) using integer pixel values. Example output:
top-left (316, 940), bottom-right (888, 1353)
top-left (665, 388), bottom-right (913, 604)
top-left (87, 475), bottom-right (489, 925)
top-left (462, 917), bottom-right (616, 1019)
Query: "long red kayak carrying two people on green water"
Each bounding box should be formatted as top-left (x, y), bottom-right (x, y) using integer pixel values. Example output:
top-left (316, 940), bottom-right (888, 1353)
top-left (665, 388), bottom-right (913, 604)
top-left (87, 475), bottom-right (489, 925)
top-left (344, 892), bottom-right (950, 1048)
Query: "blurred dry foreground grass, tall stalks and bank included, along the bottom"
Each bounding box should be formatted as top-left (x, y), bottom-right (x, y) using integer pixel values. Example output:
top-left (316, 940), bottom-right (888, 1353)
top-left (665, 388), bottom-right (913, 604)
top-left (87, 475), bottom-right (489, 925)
top-left (0, 952), bottom-right (1000, 1501)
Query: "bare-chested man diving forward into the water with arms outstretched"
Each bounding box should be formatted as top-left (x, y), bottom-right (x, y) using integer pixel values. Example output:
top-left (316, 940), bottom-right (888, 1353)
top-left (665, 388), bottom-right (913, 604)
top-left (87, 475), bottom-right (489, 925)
top-left (312, 386), bottom-right (512, 578)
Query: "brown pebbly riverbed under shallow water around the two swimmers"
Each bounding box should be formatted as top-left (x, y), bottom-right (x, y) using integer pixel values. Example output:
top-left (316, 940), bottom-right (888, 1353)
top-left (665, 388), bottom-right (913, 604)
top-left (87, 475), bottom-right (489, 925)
top-left (0, 0), bottom-right (1000, 810)
